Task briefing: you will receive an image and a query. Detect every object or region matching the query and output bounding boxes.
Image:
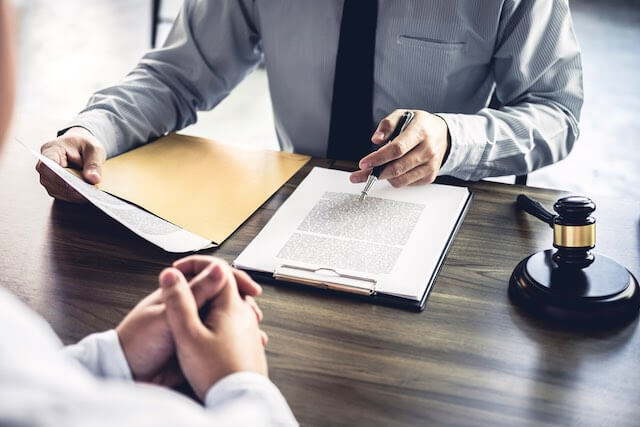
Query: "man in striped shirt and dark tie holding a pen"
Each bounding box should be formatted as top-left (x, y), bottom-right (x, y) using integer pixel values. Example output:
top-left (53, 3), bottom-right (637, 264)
top-left (38, 0), bottom-right (583, 201)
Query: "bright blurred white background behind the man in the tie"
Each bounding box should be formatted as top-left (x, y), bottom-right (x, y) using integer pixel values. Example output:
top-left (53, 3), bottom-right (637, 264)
top-left (6, 0), bottom-right (640, 200)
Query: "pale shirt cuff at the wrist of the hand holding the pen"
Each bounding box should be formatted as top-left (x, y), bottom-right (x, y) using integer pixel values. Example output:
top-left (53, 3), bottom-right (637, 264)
top-left (436, 113), bottom-right (487, 181)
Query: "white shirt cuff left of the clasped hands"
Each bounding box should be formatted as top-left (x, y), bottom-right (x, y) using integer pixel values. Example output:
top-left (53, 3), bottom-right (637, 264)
top-left (62, 329), bottom-right (133, 381)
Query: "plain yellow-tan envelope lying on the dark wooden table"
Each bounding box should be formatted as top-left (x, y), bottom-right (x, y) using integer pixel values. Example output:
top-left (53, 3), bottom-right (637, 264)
top-left (99, 134), bottom-right (310, 245)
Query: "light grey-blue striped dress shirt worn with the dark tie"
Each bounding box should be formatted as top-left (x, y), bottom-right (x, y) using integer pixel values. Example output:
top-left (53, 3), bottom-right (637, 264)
top-left (63, 0), bottom-right (583, 180)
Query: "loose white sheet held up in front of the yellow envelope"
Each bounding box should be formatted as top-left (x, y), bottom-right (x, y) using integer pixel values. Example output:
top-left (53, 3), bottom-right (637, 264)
top-left (18, 141), bottom-right (213, 253)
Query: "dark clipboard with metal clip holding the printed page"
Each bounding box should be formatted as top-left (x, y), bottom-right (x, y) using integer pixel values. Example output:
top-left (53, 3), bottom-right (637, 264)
top-left (238, 184), bottom-right (473, 312)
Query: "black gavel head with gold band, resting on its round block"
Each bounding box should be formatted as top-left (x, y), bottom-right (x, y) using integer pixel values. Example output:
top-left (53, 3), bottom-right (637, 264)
top-left (553, 196), bottom-right (596, 268)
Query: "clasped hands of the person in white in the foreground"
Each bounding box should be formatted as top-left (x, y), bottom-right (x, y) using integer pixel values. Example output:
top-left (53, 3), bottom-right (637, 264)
top-left (116, 255), bottom-right (267, 400)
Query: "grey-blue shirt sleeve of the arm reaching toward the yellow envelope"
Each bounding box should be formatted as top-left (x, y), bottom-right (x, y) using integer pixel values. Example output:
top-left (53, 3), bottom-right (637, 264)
top-left (65, 0), bottom-right (260, 157)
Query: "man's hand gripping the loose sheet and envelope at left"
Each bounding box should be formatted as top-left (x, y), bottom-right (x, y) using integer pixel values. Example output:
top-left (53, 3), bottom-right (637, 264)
top-left (36, 127), bottom-right (107, 203)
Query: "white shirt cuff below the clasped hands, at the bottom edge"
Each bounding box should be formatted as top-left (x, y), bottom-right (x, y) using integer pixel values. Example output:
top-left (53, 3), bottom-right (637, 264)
top-left (204, 371), bottom-right (298, 426)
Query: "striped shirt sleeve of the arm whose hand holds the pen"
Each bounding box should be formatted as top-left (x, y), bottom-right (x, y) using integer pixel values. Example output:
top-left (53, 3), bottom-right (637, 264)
top-left (439, 0), bottom-right (583, 180)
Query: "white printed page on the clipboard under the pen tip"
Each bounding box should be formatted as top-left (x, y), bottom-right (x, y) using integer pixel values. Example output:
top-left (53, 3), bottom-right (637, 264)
top-left (234, 167), bottom-right (469, 301)
